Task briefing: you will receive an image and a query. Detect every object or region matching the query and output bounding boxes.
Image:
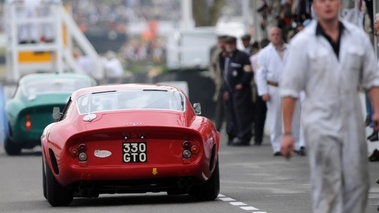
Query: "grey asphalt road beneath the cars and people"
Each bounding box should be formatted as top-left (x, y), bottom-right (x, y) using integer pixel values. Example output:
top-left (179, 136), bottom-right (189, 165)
top-left (0, 129), bottom-right (379, 213)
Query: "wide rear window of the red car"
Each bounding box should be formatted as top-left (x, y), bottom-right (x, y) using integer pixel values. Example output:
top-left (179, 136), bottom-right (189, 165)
top-left (77, 90), bottom-right (184, 114)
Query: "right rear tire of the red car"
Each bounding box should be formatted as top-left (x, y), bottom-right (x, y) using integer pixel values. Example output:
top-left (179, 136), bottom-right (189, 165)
top-left (189, 161), bottom-right (220, 201)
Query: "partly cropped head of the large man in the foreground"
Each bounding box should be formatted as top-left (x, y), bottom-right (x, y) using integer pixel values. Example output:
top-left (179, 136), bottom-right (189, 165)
top-left (313, 0), bottom-right (342, 22)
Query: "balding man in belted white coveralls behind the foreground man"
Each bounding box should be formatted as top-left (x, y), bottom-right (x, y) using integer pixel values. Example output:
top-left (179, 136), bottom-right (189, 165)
top-left (256, 27), bottom-right (304, 156)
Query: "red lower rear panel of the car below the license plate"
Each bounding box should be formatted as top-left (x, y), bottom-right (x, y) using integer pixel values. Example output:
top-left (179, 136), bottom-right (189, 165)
top-left (57, 161), bottom-right (211, 186)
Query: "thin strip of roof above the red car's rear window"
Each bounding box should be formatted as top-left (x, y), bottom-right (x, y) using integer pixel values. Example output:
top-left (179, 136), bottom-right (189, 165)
top-left (72, 84), bottom-right (184, 97)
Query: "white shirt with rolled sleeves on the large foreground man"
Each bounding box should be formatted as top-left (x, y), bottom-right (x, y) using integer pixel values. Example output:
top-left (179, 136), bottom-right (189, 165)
top-left (280, 21), bottom-right (379, 133)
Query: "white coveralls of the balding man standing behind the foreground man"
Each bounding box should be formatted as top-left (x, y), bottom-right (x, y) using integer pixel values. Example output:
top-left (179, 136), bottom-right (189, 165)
top-left (255, 43), bottom-right (304, 153)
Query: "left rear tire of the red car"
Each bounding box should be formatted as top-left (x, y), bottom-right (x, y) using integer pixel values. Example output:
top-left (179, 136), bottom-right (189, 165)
top-left (45, 158), bottom-right (73, 206)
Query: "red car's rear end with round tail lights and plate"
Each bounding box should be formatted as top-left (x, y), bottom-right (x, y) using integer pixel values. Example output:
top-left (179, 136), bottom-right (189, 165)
top-left (56, 126), bottom-right (217, 196)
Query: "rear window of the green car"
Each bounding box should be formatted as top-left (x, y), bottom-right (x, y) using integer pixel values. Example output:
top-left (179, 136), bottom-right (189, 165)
top-left (23, 79), bottom-right (91, 98)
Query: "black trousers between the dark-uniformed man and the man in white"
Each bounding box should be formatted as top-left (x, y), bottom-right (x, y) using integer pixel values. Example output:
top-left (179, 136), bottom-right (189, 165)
top-left (254, 94), bottom-right (267, 143)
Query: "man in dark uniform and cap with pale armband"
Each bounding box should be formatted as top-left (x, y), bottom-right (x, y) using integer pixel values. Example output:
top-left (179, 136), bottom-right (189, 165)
top-left (222, 36), bottom-right (253, 146)
